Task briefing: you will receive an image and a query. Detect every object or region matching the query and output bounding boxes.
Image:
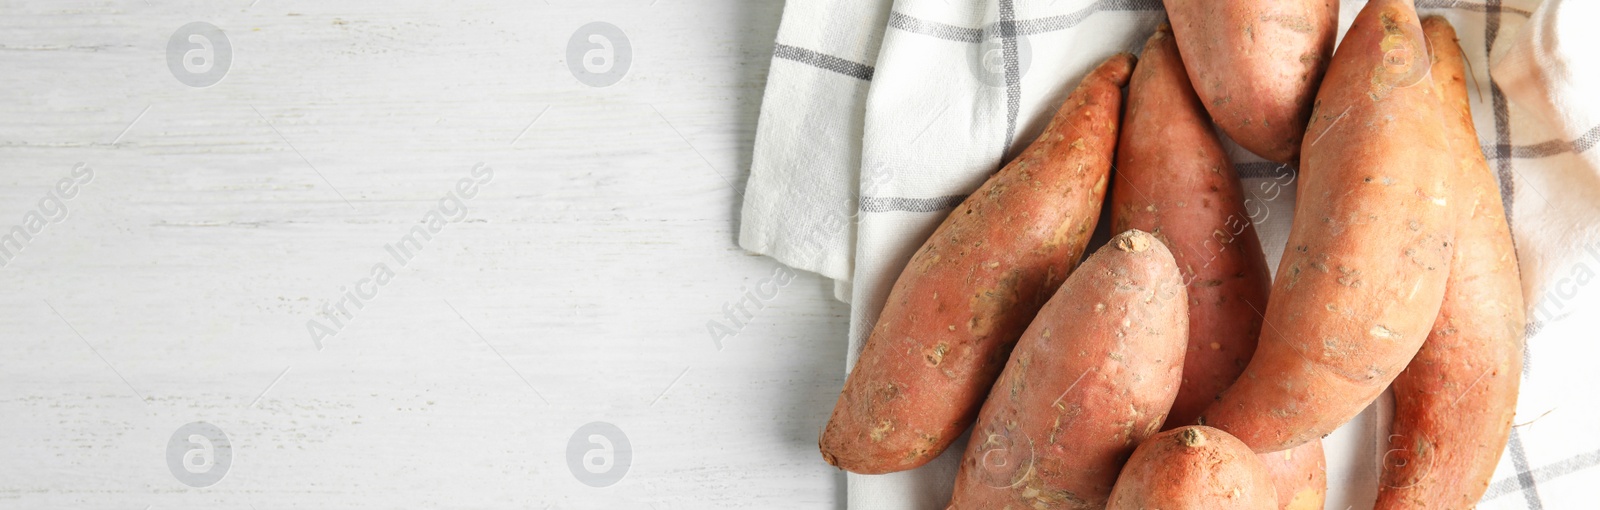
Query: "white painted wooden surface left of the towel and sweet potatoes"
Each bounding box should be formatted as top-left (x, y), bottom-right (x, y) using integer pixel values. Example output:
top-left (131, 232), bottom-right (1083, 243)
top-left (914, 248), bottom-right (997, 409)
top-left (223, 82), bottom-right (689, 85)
top-left (0, 0), bottom-right (848, 510)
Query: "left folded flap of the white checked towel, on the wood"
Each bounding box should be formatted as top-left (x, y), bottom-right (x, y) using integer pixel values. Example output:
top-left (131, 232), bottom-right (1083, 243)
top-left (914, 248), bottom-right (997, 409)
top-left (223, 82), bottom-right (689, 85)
top-left (739, 0), bottom-right (890, 301)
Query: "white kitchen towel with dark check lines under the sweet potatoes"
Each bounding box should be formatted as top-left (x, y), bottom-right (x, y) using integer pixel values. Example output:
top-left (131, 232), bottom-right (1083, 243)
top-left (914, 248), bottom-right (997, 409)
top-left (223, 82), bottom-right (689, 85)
top-left (741, 0), bottom-right (1600, 510)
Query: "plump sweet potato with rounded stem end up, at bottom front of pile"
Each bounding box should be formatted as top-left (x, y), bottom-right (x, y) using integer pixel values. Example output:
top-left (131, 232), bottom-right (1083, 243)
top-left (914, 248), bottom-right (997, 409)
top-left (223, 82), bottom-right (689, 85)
top-left (950, 230), bottom-right (1189, 508)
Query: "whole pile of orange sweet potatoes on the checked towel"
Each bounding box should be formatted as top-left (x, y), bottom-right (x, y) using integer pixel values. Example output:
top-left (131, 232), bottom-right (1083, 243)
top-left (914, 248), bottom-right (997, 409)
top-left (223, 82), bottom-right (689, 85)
top-left (819, 0), bottom-right (1523, 508)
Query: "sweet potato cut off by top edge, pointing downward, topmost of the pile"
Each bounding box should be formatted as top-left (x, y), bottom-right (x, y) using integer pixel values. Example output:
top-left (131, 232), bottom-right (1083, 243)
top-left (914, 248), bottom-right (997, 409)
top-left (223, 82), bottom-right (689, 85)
top-left (1165, 0), bottom-right (1339, 163)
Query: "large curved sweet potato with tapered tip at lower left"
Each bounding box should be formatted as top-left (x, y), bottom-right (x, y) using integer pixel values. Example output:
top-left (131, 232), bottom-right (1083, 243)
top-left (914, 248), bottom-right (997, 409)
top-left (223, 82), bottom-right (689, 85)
top-left (1200, 0), bottom-right (1456, 452)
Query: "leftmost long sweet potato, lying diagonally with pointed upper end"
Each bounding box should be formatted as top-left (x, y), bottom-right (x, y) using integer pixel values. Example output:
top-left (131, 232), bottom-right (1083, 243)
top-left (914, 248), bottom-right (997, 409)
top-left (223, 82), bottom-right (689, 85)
top-left (819, 54), bottom-right (1134, 473)
